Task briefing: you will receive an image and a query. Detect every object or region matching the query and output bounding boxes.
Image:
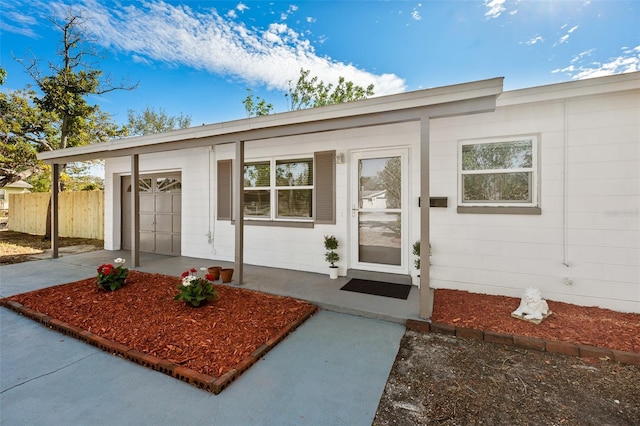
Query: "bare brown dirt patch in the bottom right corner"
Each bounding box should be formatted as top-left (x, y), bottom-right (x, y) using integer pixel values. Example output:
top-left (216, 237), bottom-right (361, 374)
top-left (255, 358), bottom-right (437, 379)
top-left (373, 330), bottom-right (640, 425)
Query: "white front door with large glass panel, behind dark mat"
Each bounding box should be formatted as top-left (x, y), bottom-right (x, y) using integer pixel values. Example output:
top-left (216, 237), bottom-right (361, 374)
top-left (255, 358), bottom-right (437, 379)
top-left (351, 149), bottom-right (408, 274)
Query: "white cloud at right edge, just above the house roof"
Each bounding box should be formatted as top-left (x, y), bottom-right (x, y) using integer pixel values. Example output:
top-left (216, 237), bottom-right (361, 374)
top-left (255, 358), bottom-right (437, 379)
top-left (551, 45), bottom-right (640, 80)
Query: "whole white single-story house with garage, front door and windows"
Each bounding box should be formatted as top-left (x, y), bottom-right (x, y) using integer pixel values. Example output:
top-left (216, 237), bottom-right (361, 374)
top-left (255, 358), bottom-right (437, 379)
top-left (40, 73), bottom-right (640, 317)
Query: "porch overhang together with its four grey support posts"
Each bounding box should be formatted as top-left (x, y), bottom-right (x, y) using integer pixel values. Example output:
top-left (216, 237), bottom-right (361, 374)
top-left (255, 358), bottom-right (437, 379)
top-left (38, 77), bottom-right (503, 318)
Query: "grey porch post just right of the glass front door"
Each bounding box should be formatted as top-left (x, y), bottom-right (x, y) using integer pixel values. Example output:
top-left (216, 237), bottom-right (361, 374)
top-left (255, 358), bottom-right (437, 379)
top-left (420, 117), bottom-right (433, 319)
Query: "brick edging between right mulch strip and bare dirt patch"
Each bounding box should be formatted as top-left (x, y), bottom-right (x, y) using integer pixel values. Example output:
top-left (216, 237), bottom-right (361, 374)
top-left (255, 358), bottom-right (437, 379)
top-left (405, 319), bottom-right (640, 365)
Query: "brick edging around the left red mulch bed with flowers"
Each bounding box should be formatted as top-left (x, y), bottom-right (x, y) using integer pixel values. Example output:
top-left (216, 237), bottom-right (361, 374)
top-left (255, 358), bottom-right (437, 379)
top-left (0, 298), bottom-right (318, 395)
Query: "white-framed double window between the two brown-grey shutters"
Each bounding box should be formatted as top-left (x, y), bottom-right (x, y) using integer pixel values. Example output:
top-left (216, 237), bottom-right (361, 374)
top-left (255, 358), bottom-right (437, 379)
top-left (244, 158), bottom-right (313, 220)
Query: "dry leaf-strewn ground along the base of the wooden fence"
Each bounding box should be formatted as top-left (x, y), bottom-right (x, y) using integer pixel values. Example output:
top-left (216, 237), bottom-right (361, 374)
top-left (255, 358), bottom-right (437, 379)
top-left (0, 229), bottom-right (104, 265)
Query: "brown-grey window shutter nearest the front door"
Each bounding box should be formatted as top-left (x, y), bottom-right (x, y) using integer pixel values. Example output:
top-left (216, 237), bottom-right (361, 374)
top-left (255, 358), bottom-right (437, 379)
top-left (313, 151), bottom-right (336, 225)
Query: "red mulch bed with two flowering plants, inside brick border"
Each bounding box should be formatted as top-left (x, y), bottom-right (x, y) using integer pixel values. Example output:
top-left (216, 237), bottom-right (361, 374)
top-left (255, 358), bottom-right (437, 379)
top-left (7, 270), bottom-right (314, 377)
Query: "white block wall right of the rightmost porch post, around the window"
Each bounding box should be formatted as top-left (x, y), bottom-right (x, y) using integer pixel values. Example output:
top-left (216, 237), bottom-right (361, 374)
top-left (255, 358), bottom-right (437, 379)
top-left (430, 91), bottom-right (640, 312)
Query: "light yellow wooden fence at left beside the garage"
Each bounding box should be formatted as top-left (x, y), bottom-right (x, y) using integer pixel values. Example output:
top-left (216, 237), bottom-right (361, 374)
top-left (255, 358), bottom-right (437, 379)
top-left (8, 191), bottom-right (104, 240)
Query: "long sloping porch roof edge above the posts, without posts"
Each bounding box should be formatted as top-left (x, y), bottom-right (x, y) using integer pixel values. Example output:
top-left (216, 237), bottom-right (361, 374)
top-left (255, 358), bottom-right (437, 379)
top-left (38, 77), bottom-right (504, 164)
